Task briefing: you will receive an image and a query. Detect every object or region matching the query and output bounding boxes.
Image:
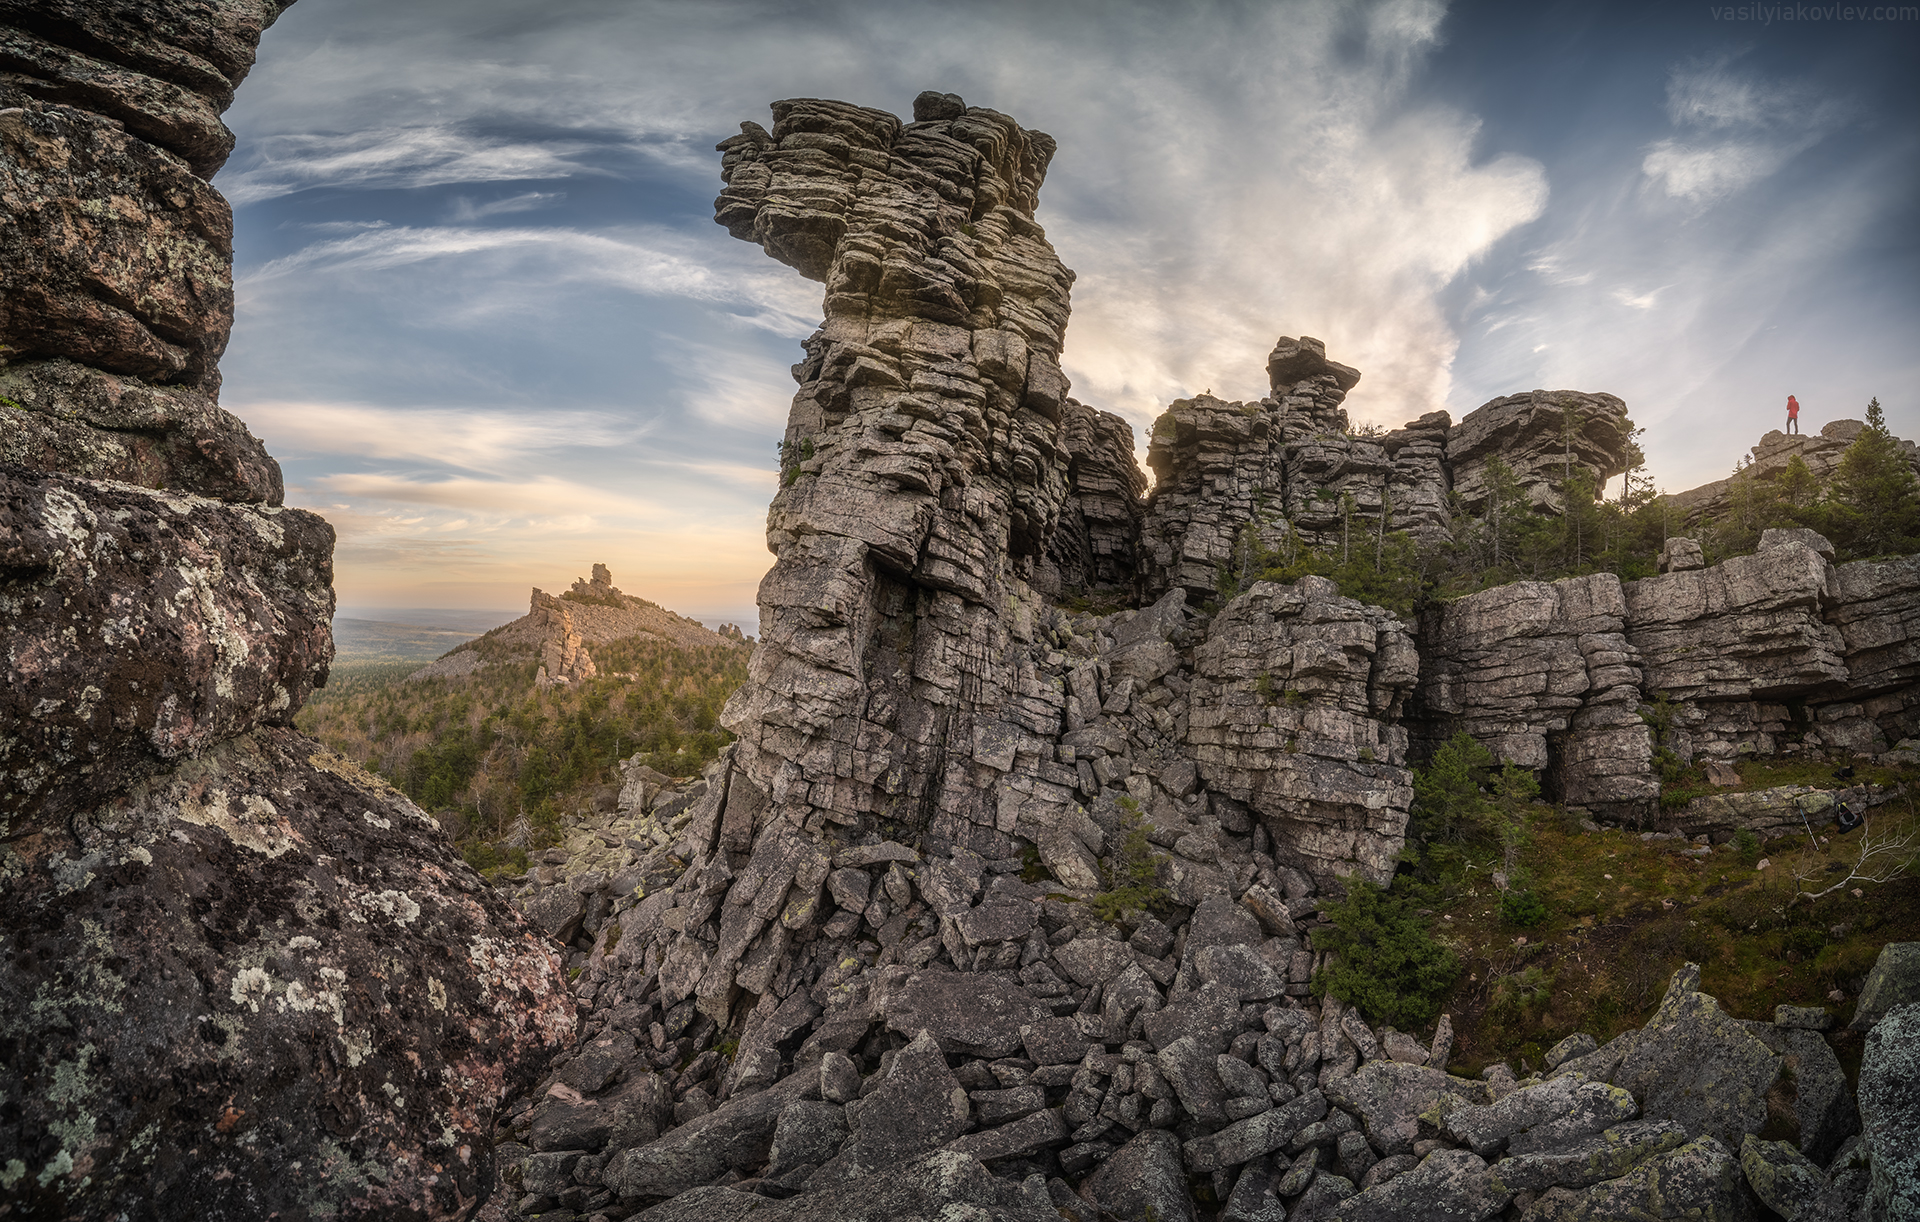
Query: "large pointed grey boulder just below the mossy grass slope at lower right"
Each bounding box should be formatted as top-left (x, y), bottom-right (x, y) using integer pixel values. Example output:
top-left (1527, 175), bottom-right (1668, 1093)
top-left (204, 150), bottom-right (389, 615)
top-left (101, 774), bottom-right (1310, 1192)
top-left (1613, 963), bottom-right (1782, 1147)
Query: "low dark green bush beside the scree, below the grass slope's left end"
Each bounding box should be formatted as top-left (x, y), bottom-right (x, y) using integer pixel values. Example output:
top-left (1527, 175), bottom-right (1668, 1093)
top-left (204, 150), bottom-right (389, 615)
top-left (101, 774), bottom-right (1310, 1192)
top-left (1313, 878), bottom-right (1459, 1028)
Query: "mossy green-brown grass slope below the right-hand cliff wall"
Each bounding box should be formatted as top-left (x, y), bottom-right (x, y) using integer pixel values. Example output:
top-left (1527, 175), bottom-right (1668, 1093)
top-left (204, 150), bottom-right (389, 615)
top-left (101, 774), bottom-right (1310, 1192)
top-left (1436, 776), bottom-right (1920, 1072)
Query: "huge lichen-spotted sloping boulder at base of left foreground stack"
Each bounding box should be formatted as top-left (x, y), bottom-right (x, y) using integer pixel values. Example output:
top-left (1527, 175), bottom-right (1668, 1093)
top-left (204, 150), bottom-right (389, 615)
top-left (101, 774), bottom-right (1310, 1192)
top-left (0, 728), bottom-right (574, 1218)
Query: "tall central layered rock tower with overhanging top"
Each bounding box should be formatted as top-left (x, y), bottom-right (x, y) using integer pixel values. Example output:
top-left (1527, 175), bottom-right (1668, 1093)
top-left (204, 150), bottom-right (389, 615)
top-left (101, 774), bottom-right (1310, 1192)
top-left (716, 90), bottom-right (1091, 838)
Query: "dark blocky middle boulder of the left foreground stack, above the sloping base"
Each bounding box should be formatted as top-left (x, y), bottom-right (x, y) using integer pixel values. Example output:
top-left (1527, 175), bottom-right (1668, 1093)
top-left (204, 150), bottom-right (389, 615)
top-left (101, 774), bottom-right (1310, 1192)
top-left (0, 471), bottom-right (334, 834)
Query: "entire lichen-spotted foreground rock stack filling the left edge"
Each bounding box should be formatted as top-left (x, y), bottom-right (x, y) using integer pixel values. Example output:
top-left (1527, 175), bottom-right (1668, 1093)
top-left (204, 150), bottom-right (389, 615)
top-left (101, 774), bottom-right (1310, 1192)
top-left (0, 2), bottom-right (574, 1218)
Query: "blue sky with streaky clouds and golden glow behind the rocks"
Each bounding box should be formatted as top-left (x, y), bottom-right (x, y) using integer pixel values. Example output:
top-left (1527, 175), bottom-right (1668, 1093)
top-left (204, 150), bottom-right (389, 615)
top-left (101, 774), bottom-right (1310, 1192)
top-left (215, 0), bottom-right (1920, 632)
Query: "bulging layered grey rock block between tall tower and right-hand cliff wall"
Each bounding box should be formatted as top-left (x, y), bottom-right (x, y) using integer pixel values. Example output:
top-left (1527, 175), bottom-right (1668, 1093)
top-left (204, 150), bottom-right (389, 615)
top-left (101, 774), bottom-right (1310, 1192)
top-left (1188, 576), bottom-right (1419, 886)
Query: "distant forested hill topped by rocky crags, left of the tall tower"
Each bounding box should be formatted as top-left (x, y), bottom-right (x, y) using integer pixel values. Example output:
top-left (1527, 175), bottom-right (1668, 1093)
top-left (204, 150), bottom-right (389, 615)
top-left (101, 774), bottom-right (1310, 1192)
top-left (298, 565), bottom-right (753, 868)
